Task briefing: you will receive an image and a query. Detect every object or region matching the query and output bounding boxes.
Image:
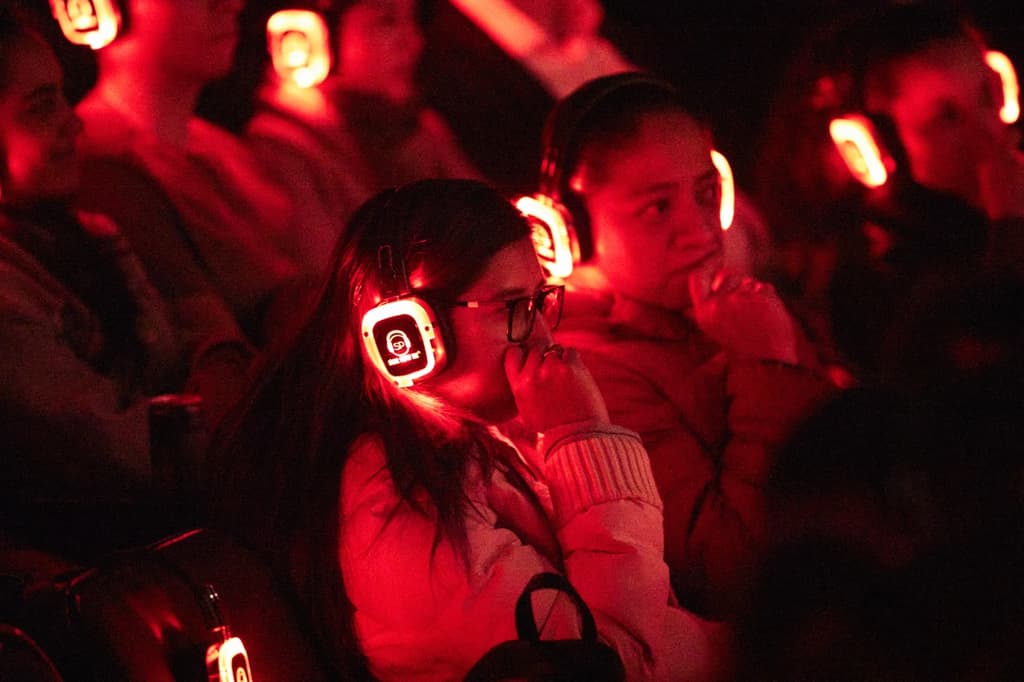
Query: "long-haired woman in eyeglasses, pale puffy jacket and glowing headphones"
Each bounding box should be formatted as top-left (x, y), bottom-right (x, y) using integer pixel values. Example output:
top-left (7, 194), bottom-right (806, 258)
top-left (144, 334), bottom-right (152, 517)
top-left (207, 180), bottom-right (714, 680)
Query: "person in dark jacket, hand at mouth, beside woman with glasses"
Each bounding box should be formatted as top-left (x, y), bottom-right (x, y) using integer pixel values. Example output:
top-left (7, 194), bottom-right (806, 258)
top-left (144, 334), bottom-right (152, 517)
top-left (542, 74), bottom-right (829, 616)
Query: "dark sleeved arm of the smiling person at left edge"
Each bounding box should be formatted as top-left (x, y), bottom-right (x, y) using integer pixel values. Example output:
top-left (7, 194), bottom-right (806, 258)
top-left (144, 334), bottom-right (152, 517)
top-left (0, 281), bottom-right (150, 493)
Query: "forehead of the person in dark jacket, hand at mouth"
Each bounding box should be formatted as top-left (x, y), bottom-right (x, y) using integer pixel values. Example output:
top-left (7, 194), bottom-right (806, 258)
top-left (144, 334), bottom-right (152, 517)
top-left (580, 112), bottom-right (714, 194)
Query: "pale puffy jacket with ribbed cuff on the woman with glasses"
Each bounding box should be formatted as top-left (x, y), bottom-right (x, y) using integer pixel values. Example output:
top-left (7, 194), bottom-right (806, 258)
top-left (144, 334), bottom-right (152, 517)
top-left (341, 425), bottom-right (711, 679)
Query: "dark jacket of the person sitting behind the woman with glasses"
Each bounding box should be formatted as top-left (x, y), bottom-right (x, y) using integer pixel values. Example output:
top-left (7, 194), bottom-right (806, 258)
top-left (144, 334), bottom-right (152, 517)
top-left (587, 349), bottom-right (828, 616)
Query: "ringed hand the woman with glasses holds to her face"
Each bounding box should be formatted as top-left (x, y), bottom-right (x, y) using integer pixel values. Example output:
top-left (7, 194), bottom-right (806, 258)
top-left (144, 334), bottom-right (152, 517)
top-left (505, 343), bottom-right (608, 433)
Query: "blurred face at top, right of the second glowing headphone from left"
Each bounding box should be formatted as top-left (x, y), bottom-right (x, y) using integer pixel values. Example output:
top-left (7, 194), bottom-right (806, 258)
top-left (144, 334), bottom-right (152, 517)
top-left (338, 0), bottom-right (423, 99)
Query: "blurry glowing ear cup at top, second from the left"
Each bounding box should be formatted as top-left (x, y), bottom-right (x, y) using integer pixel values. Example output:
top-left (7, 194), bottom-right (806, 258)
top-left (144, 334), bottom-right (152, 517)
top-left (266, 9), bottom-right (331, 88)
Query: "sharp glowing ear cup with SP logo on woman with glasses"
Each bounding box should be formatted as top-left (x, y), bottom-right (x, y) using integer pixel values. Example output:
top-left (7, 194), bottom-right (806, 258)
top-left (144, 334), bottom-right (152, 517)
top-left (362, 246), bottom-right (447, 388)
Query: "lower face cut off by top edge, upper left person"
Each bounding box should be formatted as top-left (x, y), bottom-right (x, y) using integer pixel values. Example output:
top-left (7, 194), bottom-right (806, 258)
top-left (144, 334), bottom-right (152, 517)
top-left (124, 0), bottom-right (243, 83)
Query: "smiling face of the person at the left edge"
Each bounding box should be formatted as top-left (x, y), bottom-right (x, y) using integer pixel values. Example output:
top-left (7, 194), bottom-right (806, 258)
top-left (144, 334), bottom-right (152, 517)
top-left (0, 37), bottom-right (82, 204)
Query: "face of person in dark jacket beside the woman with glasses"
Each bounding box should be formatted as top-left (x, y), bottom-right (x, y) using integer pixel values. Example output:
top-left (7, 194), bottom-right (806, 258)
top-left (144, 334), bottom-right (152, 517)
top-left (572, 112), bottom-right (722, 310)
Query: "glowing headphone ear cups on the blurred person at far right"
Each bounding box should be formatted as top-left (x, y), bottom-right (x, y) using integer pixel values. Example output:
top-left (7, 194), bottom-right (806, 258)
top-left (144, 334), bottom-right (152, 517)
top-left (828, 50), bottom-right (1020, 189)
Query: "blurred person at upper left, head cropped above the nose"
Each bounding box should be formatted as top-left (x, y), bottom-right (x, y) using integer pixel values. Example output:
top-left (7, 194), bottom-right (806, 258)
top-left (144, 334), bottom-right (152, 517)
top-left (72, 0), bottom-right (299, 344)
